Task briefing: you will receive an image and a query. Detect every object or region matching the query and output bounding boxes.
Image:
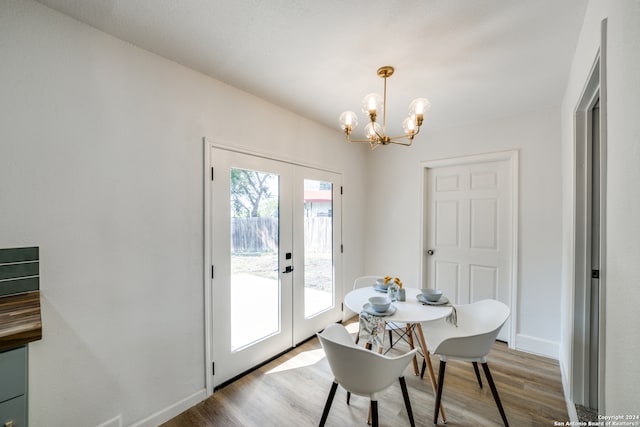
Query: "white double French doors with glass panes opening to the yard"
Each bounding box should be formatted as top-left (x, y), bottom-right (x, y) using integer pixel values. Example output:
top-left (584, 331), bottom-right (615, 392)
top-left (210, 148), bottom-right (342, 387)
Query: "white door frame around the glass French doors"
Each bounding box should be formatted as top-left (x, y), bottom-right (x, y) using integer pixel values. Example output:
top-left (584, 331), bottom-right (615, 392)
top-left (202, 137), bottom-right (344, 397)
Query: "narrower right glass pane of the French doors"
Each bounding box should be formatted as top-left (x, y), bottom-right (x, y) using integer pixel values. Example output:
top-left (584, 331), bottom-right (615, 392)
top-left (304, 179), bottom-right (335, 319)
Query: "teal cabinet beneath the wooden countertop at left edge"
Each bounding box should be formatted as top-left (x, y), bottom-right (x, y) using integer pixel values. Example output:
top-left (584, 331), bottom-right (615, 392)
top-left (0, 345), bottom-right (28, 427)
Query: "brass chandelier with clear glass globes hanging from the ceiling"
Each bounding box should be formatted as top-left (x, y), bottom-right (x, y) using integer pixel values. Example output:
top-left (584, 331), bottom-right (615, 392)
top-left (340, 65), bottom-right (431, 150)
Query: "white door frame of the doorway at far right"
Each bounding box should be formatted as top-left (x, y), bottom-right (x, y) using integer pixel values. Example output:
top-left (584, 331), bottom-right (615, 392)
top-left (568, 19), bottom-right (607, 413)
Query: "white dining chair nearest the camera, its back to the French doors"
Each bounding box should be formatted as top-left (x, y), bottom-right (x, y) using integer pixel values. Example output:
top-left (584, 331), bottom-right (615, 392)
top-left (317, 323), bottom-right (416, 427)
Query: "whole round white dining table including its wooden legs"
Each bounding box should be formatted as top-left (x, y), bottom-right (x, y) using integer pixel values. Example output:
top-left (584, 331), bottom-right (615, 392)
top-left (344, 286), bottom-right (453, 422)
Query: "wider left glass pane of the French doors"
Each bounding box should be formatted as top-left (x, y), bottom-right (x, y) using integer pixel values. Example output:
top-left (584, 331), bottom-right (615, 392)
top-left (230, 168), bottom-right (280, 351)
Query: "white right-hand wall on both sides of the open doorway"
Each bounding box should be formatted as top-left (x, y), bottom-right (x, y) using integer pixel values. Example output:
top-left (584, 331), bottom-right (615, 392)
top-left (560, 0), bottom-right (640, 415)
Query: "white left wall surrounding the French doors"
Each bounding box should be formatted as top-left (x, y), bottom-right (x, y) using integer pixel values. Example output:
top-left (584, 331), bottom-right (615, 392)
top-left (0, 0), bottom-right (365, 427)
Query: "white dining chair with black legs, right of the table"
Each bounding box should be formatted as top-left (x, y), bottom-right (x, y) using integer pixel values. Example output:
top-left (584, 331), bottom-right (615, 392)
top-left (422, 300), bottom-right (511, 427)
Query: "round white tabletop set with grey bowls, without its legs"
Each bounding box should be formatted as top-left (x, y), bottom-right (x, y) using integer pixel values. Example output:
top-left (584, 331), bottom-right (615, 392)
top-left (344, 286), bottom-right (452, 323)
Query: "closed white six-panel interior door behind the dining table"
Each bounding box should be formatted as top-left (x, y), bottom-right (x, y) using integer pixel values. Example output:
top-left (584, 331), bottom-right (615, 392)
top-left (424, 160), bottom-right (513, 341)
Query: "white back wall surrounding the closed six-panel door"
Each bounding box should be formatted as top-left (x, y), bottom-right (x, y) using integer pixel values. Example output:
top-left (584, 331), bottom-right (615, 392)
top-left (365, 108), bottom-right (562, 357)
